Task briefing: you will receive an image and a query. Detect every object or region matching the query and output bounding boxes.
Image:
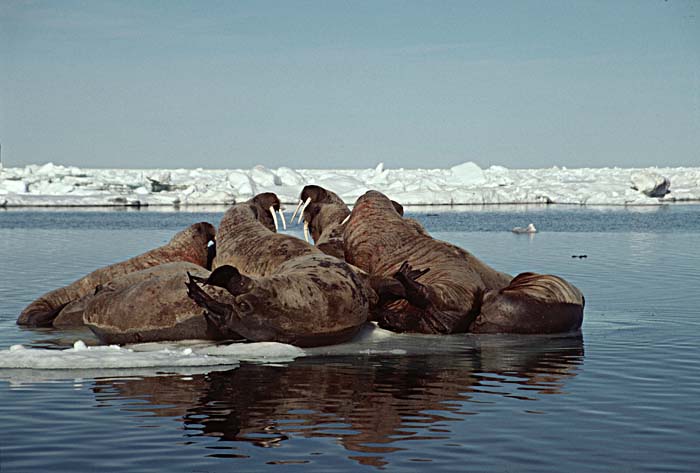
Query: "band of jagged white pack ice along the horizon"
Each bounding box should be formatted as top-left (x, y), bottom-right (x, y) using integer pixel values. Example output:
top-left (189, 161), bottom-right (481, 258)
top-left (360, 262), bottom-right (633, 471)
top-left (0, 162), bottom-right (700, 206)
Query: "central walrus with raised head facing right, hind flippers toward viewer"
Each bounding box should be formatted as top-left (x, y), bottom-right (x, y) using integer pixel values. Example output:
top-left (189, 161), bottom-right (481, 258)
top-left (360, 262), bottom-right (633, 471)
top-left (187, 195), bottom-right (373, 346)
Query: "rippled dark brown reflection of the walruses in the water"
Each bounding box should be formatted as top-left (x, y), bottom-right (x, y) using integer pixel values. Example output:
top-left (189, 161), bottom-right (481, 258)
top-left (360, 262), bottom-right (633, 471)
top-left (93, 335), bottom-right (583, 466)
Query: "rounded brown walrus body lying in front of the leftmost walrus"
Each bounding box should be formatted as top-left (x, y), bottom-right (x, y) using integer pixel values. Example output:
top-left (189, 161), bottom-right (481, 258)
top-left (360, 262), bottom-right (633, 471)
top-left (83, 262), bottom-right (228, 344)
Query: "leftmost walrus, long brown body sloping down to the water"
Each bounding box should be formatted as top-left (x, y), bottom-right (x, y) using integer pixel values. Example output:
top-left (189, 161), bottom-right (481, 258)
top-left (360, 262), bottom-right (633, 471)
top-left (17, 222), bottom-right (215, 327)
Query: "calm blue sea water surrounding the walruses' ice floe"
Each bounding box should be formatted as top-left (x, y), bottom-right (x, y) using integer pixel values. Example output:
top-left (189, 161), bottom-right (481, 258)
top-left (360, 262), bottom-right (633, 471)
top-left (0, 205), bottom-right (700, 473)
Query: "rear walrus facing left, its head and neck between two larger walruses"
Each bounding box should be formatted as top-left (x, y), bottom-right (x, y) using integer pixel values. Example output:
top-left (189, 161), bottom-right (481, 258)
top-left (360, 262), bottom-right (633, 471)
top-left (300, 185), bottom-right (350, 259)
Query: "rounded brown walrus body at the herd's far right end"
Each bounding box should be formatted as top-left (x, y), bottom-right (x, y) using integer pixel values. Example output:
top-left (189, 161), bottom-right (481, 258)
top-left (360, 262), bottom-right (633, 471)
top-left (469, 273), bottom-right (585, 334)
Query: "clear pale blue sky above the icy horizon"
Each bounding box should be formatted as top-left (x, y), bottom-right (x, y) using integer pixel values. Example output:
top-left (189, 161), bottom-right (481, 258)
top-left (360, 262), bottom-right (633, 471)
top-left (0, 0), bottom-right (700, 168)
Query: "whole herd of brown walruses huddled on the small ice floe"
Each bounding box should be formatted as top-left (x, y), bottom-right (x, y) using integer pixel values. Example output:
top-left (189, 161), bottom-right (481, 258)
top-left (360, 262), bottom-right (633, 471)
top-left (17, 186), bottom-right (585, 347)
